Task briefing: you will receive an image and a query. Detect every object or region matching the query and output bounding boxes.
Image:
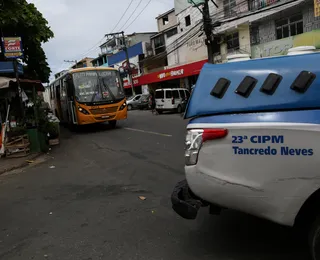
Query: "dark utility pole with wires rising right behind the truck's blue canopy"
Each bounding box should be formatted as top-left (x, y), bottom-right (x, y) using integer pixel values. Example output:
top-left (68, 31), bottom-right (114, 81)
top-left (188, 0), bottom-right (218, 64)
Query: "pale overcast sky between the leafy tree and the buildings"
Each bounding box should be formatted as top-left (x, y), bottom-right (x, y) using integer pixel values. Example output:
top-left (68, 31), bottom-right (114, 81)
top-left (27, 0), bottom-right (174, 81)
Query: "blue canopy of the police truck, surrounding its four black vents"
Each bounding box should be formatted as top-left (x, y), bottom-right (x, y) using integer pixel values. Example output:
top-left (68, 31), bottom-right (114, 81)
top-left (185, 53), bottom-right (320, 118)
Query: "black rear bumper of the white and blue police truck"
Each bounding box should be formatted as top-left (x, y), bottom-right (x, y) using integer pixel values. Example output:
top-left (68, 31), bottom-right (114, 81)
top-left (171, 180), bottom-right (205, 219)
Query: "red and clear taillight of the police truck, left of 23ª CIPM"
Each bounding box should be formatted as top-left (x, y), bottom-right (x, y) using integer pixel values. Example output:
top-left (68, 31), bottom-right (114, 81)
top-left (185, 129), bottom-right (228, 165)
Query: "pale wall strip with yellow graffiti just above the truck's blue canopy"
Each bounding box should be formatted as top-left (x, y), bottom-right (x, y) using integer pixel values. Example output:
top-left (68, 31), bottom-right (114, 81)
top-left (251, 30), bottom-right (320, 58)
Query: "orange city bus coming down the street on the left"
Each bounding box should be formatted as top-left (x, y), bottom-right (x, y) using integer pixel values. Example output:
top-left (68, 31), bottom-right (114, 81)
top-left (48, 67), bottom-right (127, 128)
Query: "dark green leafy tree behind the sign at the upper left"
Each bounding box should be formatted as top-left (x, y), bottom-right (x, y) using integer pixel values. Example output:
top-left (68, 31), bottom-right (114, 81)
top-left (0, 0), bottom-right (54, 82)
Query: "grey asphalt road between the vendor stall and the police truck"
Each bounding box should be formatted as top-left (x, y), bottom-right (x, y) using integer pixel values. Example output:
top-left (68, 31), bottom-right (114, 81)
top-left (0, 111), bottom-right (306, 260)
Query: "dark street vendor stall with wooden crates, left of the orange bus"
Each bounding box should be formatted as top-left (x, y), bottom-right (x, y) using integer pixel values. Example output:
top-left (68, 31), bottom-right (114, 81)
top-left (0, 77), bottom-right (59, 157)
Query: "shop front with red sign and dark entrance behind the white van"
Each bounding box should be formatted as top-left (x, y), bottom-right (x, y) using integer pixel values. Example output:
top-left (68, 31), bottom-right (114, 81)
top-left (124, 60), bottom-right (207, 94)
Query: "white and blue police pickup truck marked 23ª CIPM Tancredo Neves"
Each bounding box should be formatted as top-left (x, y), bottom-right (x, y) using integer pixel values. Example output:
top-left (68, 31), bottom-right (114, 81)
top-left (171, 53), bottom-right (320, 260)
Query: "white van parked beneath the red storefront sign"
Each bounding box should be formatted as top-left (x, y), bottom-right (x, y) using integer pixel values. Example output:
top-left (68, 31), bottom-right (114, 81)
top-left (155, 88), bottom-right (190, 114)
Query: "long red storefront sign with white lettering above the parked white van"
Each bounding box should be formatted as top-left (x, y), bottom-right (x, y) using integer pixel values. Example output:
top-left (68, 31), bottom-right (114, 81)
top-left (124, 60), bottom-right (208, 88)
